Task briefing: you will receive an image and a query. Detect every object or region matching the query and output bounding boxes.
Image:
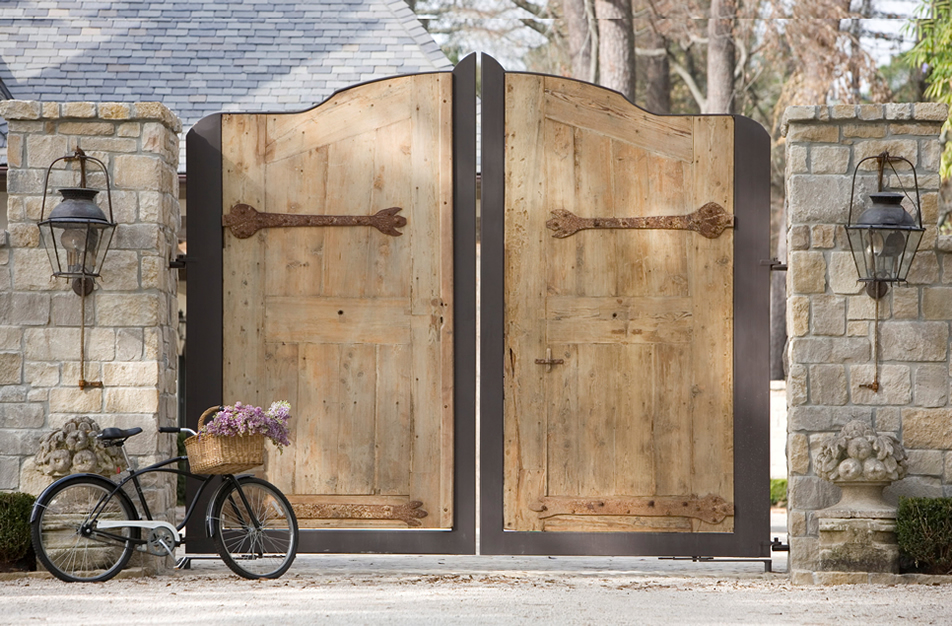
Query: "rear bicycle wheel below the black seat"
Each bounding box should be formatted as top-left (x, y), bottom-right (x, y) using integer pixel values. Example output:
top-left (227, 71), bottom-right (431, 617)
top-left (30, 475), bottom-right (139, 582)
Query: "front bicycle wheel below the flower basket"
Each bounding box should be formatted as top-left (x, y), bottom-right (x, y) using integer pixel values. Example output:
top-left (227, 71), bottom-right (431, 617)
top-left (211, 476), bottom-right (298, 578)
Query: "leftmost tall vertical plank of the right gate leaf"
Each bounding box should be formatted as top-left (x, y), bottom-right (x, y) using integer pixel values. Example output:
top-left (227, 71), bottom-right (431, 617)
top-left (503, 74), bottom-right (549, 530)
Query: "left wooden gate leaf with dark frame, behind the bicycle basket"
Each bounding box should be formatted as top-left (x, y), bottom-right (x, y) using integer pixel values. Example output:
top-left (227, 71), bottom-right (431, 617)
top-left (187, 58), bottom-right (475, 553)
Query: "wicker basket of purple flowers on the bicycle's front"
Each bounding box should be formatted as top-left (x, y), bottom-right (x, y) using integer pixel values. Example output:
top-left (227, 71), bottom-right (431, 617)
top-left (185, 401), bottom-right (291, 474)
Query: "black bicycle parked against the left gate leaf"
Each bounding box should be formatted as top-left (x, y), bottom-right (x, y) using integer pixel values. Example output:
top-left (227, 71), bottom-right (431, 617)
top-left (30, 420), bottom-right (298, 582)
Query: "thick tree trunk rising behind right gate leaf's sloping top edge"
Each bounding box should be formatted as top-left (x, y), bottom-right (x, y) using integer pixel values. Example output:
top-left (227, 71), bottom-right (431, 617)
top-left (595, 0), bottom-right (635, 102)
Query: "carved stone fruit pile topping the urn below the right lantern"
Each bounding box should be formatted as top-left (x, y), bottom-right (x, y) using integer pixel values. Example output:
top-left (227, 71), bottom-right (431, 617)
top-left (816, 420), bottom-right (907, 485)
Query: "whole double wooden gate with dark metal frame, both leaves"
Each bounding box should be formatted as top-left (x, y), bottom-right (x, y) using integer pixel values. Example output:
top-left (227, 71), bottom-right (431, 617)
top-left (187, 56), bottom-right (769, 556)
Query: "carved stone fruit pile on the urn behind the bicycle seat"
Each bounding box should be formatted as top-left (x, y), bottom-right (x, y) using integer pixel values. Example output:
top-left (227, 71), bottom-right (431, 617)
top-left (34, 417), bottom-right (123, 476)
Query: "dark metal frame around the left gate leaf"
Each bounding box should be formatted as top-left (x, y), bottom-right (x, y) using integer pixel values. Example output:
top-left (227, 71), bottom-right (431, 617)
top-left (186, 54), bottom-right (476, 554)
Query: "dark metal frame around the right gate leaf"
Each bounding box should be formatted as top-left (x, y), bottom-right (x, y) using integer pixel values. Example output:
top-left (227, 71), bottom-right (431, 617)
top-left (480, 55), bottom-right (770, 557)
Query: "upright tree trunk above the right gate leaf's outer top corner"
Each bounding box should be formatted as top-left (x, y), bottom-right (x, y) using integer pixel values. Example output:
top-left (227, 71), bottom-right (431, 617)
top-left (704, 0), bottom-right (737, 113)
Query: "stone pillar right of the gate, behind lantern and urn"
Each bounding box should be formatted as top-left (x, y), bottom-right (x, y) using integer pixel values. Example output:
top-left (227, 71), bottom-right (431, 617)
top-left (784, 103), bottom-right (952, 578)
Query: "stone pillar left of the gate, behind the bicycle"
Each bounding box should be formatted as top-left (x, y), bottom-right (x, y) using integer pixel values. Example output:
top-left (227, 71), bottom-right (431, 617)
top-left (0, 101), bottom-right (181, 532)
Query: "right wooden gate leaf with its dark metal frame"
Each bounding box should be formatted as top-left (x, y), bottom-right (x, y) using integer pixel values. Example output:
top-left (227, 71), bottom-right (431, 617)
top-left (481, 57), bottom-right (769, 556)
